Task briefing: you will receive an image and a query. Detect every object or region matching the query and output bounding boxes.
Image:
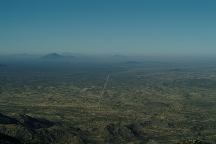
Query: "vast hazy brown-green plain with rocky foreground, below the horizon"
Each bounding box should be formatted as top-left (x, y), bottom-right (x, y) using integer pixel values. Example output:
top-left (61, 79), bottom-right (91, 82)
top-left (0, 54), bottom-right (216, 144)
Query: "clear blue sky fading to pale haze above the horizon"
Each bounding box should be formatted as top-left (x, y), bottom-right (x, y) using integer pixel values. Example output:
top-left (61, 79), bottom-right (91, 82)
top-left (0, 0), bottom-right (216, 56)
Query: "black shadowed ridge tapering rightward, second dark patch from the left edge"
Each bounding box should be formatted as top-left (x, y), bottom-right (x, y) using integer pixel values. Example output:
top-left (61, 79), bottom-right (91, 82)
top-left (18, 115), bottom-right (55, 129)
